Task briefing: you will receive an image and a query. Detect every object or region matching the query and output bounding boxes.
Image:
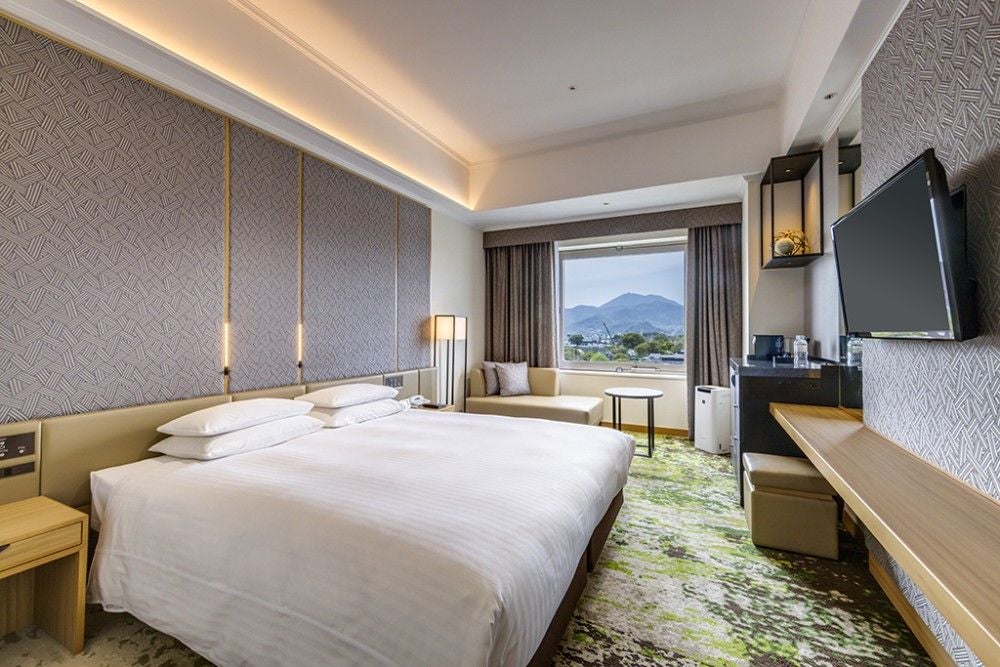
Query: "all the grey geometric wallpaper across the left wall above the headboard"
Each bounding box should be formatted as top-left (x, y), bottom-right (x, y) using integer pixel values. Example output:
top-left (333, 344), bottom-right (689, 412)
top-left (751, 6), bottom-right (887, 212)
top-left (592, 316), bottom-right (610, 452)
top-left (0, 19), bottom-right (430, 423)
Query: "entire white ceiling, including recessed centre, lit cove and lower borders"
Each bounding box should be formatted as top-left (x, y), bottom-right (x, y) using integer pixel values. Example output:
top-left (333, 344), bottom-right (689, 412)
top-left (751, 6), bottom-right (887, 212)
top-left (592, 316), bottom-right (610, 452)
top-left (0, 0), bottom-right (906, 228)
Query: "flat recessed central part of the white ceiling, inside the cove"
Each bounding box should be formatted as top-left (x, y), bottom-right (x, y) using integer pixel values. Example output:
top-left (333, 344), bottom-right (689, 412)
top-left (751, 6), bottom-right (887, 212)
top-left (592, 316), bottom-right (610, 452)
top-left (230, 0), bottom-right (808, 163)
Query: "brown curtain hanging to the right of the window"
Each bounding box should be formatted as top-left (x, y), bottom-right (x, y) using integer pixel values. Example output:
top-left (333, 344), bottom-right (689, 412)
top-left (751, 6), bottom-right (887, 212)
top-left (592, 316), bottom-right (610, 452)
top-left (685, 225), bottom-right (743, 438)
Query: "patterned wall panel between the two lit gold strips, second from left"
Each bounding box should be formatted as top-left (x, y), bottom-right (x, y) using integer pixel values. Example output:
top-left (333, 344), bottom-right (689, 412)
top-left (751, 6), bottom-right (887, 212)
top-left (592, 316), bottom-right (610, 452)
top-left (229, 122), bottom-right (299, 391)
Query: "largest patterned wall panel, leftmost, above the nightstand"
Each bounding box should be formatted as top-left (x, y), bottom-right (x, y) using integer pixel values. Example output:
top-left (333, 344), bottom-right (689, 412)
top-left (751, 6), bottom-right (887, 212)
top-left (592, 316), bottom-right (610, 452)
top-left (0, 20), bottom-right (224, 422)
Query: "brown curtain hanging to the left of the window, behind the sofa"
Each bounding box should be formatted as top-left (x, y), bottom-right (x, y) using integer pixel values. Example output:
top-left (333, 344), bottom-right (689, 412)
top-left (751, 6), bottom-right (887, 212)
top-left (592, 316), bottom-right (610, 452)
top-left (486, 243), bottom-right (556, 366)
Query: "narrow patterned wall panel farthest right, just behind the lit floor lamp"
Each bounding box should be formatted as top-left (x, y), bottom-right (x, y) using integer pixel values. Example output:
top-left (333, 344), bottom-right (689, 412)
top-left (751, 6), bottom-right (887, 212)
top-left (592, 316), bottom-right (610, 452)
top-left (396, 197), bottom-right (432, 370)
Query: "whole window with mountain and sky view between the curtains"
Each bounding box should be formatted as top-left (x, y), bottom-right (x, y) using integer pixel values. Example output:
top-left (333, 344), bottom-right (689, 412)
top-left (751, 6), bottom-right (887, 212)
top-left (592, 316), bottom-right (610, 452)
top-left (559, 243), bottom-right (687, 372)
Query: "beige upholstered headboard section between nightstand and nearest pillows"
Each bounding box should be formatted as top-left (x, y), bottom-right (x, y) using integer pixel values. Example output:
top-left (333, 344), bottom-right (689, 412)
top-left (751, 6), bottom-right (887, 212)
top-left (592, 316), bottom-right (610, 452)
top-left (41, 395), bottom-right (230, 507)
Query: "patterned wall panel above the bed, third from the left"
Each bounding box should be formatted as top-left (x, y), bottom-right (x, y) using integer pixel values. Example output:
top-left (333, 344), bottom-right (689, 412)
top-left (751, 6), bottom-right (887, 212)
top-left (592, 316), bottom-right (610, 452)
top-left (302, 156), bottom-right (396, 382)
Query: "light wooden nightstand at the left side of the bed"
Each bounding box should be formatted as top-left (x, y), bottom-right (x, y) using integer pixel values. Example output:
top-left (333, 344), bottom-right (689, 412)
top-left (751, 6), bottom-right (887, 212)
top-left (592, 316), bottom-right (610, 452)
top-left (0, 496), bottom-right (87, 653)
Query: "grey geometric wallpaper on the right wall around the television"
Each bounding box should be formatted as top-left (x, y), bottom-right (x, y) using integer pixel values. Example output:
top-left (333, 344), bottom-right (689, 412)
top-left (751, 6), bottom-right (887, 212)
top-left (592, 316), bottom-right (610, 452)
top-left (862, 0), bottom-right (1000, 665)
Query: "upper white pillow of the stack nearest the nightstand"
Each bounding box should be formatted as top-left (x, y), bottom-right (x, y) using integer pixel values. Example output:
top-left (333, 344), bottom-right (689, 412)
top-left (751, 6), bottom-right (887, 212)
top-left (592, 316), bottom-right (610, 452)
top-left (156, 398), bottom-right (312, 436)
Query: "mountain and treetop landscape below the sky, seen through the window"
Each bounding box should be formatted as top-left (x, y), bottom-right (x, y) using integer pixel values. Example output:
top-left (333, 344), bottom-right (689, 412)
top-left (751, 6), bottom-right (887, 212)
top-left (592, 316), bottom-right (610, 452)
top-left (563, 292), bottom-right (684, 364)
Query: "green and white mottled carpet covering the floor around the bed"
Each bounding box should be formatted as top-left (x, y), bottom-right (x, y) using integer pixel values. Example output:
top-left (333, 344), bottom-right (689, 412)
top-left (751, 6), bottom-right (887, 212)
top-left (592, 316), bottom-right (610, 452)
top-left (0, 438), bottom-right (931, 667)
